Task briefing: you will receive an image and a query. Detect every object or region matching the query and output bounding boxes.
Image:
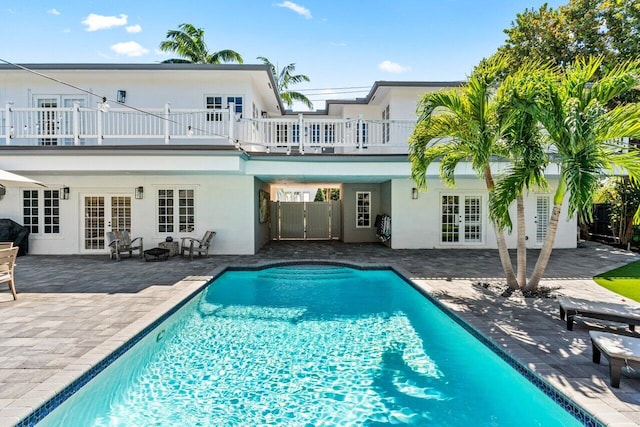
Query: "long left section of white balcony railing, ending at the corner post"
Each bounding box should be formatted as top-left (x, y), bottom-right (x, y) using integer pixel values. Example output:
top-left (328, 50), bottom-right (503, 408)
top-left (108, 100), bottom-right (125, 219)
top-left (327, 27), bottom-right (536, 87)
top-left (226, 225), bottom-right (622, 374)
top-left (0, 103), bottom-right (233, 146)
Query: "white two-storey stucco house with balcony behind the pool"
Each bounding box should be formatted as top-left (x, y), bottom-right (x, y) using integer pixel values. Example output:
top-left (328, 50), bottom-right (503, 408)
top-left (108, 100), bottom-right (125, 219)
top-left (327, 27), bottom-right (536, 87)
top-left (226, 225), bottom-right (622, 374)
top-left (0, 64), bottom-right (576, 254)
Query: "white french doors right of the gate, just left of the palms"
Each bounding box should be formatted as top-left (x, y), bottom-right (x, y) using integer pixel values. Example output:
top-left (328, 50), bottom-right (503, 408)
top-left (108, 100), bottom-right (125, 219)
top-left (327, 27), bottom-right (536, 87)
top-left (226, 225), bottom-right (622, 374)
top-left (440, 194), bottom-right (483, 244)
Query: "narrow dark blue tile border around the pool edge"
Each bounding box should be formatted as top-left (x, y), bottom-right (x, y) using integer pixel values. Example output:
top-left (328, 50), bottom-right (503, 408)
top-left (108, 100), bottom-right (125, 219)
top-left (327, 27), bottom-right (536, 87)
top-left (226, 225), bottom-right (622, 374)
top-left (15, 260), bottom-right (606, 427)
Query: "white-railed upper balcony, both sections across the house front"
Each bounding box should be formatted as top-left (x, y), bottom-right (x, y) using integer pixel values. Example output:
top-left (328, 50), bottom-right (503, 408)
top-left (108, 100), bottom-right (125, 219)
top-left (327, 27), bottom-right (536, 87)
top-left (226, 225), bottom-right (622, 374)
top-left (0, 104), bottom-right (415, 154)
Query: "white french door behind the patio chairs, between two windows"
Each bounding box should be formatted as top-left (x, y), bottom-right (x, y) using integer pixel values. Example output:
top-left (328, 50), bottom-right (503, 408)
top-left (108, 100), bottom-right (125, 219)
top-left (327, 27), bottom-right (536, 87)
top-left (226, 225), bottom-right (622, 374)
top-left (82, 195), bottom-right (131, 253)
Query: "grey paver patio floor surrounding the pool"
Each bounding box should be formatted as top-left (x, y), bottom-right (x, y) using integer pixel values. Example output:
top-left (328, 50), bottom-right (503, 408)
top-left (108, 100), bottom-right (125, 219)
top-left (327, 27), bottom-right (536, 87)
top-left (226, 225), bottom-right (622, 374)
top-left (0, 242), bottom-right (640, 427)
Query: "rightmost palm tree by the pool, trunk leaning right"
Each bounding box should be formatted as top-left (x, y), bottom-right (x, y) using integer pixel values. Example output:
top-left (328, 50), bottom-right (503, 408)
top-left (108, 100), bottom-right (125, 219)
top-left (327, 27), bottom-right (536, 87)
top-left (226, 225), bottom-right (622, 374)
top-left (525, 58), bottom-right (640, 291)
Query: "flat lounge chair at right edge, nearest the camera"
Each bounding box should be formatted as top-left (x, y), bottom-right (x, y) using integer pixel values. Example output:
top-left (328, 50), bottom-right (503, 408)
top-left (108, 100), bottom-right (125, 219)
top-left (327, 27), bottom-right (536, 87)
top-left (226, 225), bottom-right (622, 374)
top-left (589, 331), bottom-right (640, 388)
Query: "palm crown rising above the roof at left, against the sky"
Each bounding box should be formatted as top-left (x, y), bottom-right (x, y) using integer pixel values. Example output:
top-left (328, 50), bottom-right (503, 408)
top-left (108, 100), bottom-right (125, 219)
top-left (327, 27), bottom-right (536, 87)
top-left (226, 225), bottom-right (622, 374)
top-left (160, 24), bottom-right (242, 64)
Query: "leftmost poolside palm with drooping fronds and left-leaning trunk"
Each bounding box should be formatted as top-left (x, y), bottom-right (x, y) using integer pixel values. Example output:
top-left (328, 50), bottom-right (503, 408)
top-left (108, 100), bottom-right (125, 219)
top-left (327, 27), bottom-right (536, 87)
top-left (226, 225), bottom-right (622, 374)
top-left (409, 56), bottom-right (518, 289)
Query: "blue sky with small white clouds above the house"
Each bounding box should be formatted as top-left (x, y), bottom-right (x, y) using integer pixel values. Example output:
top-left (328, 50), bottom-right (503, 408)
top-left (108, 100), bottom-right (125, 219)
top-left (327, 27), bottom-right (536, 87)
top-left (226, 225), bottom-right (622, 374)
top-left (0, 0), bottom-right (566, 108)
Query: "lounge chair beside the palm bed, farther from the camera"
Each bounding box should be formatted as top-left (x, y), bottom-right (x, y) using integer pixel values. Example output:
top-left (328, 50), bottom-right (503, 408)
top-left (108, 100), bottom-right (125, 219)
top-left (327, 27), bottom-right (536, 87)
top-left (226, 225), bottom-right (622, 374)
top-left (558, 297), bottom-right (640, 331)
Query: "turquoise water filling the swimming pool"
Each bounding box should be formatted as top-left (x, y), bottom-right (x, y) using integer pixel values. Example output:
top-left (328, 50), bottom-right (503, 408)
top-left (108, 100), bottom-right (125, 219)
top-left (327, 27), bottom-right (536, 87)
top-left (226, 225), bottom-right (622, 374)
top-left (39, 266), bottom-right (592, 427)
